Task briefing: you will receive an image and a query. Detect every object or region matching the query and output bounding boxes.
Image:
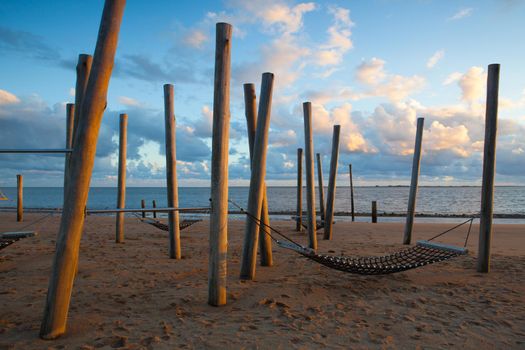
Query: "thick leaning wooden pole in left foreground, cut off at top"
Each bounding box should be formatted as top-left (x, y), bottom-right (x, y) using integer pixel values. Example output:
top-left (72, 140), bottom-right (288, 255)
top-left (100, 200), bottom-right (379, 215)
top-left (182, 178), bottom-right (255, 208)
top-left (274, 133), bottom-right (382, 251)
top-left (40, 0), bottom-right (126, 339)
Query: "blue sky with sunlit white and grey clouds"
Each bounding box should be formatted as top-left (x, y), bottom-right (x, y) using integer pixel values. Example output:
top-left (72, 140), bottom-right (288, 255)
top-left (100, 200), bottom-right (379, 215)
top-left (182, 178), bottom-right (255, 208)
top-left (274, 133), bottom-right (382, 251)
top-left (0, 0), bottom-right (525, 186)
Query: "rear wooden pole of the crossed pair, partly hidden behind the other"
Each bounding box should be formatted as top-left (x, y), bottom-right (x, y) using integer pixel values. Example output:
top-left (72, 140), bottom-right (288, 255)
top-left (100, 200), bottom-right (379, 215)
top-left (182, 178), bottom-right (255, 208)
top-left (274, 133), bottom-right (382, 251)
top-left (244, 84), bottom-right (273, 266)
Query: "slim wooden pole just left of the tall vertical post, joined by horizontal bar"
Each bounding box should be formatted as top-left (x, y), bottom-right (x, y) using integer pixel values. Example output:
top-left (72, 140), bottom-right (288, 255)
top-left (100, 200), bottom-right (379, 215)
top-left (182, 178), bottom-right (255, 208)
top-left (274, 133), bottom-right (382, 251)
top-left (164, 84), bottom-right (182, 259)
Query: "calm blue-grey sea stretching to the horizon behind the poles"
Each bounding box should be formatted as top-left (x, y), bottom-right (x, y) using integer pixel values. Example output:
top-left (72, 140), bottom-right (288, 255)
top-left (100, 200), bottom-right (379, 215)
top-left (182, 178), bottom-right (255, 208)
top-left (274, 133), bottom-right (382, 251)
top-left (0, 187), bottom-right (525, 221)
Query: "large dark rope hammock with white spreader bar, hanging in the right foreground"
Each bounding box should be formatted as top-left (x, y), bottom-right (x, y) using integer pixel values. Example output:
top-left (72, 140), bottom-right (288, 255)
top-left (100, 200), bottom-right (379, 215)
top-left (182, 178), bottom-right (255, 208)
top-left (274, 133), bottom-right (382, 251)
top-left (230, 200), bottom-right (474, 275)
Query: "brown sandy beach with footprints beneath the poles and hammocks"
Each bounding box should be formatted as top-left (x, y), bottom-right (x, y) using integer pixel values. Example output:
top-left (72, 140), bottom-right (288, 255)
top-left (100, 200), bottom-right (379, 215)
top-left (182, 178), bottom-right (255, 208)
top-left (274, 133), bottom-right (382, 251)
top-left (0, 213), bottom-right (525, 349)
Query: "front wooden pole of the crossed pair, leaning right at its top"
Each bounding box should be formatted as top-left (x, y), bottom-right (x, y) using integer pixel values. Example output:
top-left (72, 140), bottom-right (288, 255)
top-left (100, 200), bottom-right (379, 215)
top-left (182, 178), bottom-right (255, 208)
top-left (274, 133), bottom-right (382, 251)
top-left (240, 73), bottom-right (273, 280)
